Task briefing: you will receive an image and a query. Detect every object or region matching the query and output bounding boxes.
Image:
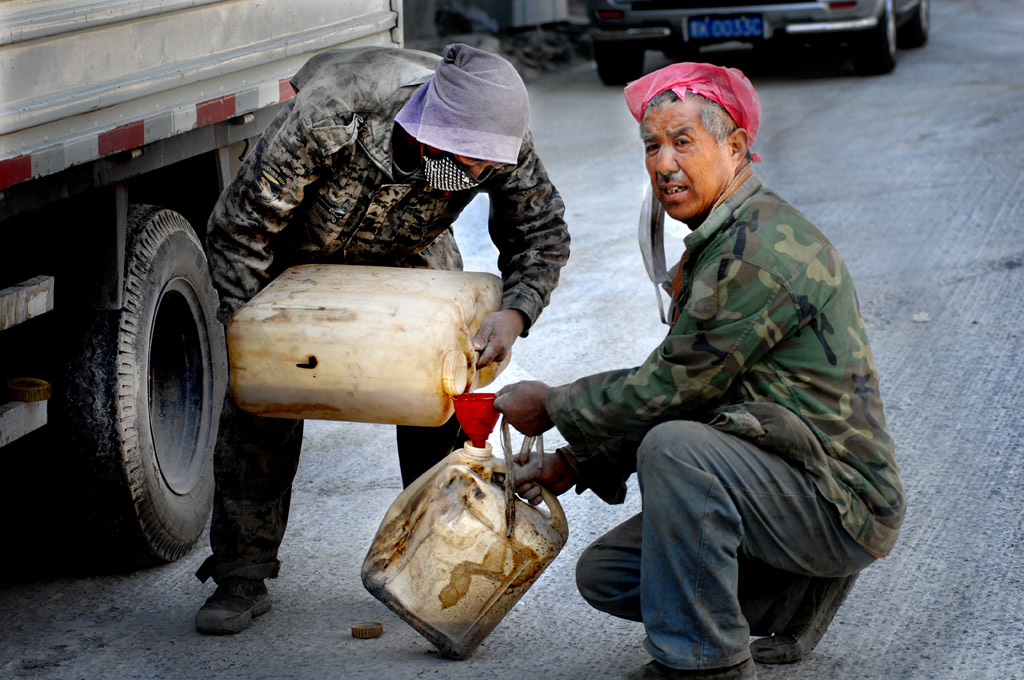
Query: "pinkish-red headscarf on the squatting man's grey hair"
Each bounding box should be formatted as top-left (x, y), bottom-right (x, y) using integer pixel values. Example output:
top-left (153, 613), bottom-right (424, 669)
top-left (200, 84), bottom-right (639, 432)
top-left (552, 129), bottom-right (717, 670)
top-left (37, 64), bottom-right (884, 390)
top-left (626, 61), bottom-right (761, 161)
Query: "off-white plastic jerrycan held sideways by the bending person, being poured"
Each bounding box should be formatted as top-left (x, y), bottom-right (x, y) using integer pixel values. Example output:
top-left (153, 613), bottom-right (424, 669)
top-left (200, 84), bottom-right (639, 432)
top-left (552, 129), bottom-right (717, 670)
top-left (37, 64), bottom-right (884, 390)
top-left (227, 264), bottom-right (508, 427)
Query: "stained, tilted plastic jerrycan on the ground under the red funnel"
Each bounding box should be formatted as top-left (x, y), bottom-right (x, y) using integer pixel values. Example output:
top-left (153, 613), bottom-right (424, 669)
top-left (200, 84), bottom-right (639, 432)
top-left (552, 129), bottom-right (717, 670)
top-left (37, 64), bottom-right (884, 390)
top-left (362, 442), bottom-right (568, 658)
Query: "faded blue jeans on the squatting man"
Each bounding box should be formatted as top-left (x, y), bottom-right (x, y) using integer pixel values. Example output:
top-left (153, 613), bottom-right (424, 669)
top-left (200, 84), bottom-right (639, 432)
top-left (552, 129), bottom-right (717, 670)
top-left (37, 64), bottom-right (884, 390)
top-left (577, 421), bottom-right (874, 669)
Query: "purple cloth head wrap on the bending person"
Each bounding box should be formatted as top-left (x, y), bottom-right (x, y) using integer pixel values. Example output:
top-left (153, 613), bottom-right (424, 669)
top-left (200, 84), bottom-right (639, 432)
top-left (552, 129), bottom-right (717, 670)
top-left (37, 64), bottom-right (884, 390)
top-left (394, 44), bottom-right (529, 164)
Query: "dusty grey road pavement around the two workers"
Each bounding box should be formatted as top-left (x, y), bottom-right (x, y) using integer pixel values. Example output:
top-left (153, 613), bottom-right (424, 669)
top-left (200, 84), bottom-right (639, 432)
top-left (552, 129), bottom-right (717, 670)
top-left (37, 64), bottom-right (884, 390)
top-left (0, 0), bottom-right (1024, 680)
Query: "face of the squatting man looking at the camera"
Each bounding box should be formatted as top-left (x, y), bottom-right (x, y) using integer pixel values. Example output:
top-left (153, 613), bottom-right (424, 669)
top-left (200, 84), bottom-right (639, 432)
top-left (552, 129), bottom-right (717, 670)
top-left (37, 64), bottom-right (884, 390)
top-left (642, 97), bottom-right (748, 229)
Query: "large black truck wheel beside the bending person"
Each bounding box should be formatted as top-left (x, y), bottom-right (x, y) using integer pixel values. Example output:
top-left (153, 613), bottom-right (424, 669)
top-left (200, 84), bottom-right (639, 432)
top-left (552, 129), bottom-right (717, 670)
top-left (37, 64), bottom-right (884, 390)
top-left (67, 206), bottom-right (227, 565)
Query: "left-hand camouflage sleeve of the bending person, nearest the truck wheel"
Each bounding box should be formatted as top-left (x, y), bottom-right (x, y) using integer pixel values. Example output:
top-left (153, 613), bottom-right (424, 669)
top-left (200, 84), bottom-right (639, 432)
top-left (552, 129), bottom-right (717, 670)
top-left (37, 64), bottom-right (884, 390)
top-left (207, 99), bottom-right (344, 325)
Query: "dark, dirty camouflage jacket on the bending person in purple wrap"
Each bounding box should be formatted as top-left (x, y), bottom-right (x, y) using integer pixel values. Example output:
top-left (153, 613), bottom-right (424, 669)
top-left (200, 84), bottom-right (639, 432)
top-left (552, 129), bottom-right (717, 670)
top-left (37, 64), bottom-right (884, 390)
top-left (199, 47), bottom-right (569, 329)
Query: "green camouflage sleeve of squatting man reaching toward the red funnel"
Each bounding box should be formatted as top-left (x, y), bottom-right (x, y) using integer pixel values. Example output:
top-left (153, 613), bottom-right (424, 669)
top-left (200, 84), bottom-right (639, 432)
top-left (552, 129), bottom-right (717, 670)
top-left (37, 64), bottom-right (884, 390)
top-left (545, 260), bottom-right (798, 461)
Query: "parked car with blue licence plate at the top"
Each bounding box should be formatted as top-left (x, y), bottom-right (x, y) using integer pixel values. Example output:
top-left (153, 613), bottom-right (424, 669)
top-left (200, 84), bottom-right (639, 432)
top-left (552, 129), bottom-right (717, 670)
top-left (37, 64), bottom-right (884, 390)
top-left (587, 0), bottom-right (930, 85)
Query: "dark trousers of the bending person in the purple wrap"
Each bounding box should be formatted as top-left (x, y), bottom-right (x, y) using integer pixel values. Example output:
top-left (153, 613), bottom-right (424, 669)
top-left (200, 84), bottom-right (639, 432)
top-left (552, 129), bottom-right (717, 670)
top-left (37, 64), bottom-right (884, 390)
top-left (196, 394), bottom-right (465, 583)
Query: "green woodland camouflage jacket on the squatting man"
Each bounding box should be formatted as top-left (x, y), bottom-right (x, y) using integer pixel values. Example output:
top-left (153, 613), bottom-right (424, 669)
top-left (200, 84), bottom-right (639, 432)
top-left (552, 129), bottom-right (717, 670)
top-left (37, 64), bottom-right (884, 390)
top-left (546, 175), bottom-right (905, 556)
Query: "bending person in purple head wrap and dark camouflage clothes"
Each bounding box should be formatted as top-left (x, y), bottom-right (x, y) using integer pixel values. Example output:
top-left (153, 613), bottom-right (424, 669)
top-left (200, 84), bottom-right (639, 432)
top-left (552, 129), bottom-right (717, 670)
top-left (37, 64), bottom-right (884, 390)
top-left (196, 44), bottom-right (569, 634)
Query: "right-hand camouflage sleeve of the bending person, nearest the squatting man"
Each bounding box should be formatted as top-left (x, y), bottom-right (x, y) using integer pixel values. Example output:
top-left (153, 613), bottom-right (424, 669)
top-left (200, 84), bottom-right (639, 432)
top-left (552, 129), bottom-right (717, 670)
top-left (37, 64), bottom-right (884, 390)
top-left (485, 131), bottom-right (569, 335)
